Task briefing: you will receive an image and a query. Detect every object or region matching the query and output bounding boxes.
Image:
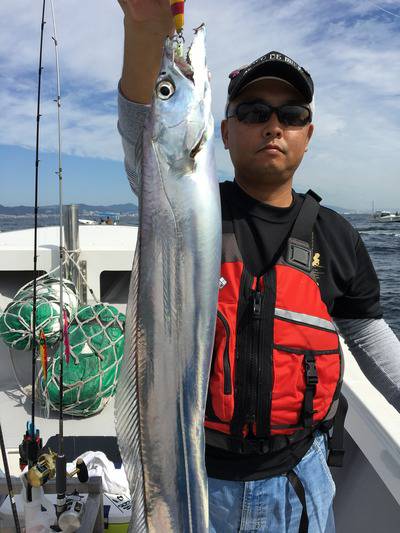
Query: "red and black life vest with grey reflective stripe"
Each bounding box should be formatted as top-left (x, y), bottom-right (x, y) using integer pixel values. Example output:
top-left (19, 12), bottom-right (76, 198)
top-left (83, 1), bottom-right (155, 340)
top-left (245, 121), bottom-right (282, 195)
top-left (205, 191), bottom-right (343, 453)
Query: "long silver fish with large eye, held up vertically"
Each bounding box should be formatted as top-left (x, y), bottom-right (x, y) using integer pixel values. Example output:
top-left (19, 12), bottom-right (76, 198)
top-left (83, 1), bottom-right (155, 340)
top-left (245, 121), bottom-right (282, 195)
top-left (115, 26), bottom-right (221, 533)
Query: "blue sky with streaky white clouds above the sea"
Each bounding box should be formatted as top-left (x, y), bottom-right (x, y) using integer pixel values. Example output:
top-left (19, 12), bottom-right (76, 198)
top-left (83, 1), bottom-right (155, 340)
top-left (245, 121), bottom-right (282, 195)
top-left (0, 0), bottom-right (400, 210)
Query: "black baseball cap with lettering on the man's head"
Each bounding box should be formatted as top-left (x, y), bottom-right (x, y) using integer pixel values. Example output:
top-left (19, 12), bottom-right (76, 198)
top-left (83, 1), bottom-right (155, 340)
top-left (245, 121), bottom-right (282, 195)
top-left (228, 52), bottom-right (314, 104)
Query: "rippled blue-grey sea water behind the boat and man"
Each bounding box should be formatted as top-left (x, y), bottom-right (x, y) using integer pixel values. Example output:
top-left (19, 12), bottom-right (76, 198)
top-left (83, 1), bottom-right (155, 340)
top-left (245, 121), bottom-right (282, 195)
top-left (0, 210), bottom-right (400, 338)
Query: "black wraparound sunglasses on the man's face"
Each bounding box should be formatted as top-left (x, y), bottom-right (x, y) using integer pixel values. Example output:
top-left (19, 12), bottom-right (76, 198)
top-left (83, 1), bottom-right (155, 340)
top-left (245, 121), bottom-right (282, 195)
top-left (226, 102), bottom-right (312, 126)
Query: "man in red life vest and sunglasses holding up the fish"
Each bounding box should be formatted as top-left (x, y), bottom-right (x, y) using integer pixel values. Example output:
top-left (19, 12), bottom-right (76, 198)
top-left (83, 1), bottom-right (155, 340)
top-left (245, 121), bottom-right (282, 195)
top-left (118, 0), bottom-right (400, 533)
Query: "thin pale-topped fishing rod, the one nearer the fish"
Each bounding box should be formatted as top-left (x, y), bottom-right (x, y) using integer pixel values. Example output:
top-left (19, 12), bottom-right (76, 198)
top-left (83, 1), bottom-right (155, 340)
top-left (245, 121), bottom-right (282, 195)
top-left (50, 0), bottom-right (68, 518)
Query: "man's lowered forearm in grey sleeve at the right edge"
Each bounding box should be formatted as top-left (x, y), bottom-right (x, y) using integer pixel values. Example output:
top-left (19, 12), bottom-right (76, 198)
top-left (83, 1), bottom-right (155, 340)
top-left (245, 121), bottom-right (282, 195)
top-left (334, 318), bottom-right (400, 412)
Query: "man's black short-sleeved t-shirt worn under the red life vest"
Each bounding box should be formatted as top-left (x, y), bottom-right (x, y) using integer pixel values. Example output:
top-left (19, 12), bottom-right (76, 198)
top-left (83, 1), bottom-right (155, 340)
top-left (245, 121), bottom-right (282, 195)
top-left (206, 181), bottom-right (382, 481)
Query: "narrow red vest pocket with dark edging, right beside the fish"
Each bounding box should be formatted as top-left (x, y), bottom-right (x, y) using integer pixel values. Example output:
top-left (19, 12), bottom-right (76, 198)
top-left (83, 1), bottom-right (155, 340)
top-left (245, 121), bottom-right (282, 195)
top-left (209, 311), bottom-right (233, 421)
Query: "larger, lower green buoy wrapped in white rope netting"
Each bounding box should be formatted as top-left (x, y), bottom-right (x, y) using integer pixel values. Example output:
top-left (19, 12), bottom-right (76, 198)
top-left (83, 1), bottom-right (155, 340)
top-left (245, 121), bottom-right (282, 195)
top-left (41, 303), bottom-right (125, 417)
